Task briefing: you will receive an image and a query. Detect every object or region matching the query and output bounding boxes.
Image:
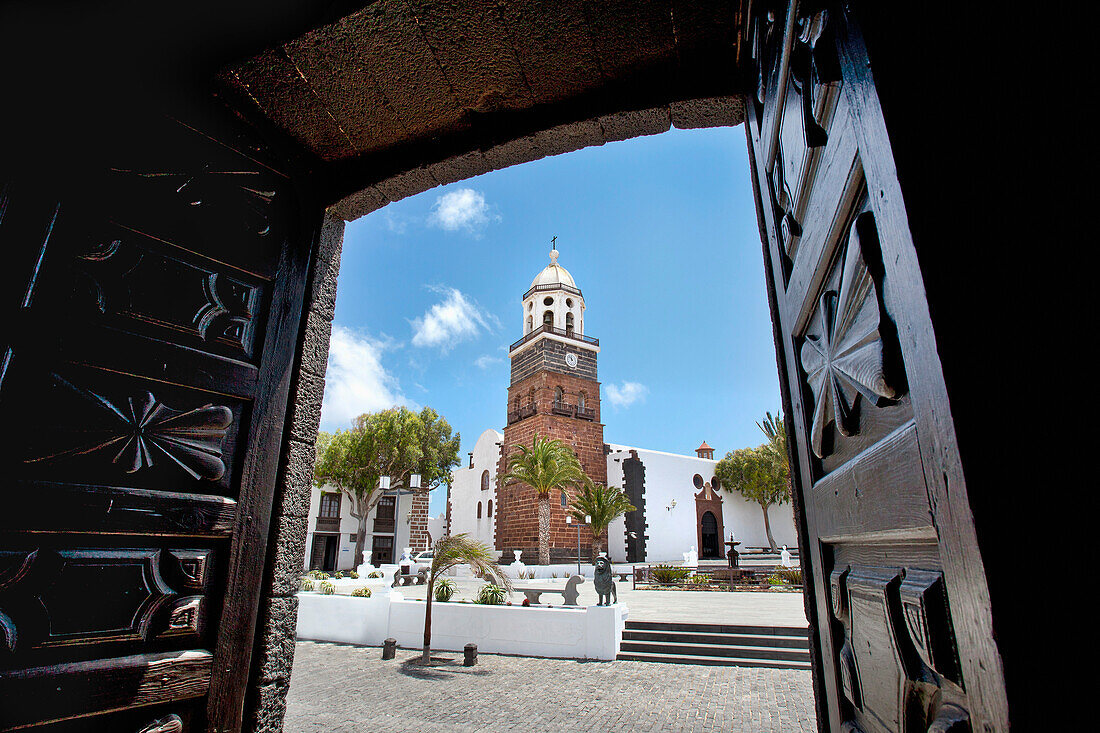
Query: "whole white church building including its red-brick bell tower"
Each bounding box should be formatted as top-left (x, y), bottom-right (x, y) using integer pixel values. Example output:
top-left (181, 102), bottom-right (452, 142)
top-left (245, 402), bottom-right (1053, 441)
top-left (447, 249), bottom-right (798, 562)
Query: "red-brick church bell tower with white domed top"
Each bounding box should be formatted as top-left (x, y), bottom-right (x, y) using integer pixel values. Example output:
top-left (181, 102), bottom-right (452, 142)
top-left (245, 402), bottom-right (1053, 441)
top-left (496, 238), bottom-right (607, 564)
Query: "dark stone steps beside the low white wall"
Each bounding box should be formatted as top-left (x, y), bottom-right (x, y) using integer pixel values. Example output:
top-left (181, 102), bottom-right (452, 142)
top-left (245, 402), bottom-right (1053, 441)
top-left (617, 621), bottom-right (810, 669)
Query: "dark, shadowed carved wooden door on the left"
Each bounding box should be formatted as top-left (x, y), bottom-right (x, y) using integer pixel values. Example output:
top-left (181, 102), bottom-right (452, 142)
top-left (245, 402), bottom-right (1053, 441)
top-left (0, 111), bottom-right (319, 733)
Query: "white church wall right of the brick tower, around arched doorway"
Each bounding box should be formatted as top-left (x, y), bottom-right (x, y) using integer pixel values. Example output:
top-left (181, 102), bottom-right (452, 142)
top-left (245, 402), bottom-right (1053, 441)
top-left (607, 446), bottom-right (798, 562)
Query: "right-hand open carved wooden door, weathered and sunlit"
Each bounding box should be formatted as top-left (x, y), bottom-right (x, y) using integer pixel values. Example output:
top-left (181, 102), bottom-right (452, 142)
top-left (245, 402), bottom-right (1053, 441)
top-left (746, 2), bottom-right (1008, 733)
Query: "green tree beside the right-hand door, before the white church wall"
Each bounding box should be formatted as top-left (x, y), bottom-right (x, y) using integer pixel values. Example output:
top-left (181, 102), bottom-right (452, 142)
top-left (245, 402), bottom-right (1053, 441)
top-left (714, 413), bottom-right (791, 550)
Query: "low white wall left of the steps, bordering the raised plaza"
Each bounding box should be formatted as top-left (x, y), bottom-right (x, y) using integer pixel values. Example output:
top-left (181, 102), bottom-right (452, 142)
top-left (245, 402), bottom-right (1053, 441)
top-left (298, 591), bottom-right (628, 659)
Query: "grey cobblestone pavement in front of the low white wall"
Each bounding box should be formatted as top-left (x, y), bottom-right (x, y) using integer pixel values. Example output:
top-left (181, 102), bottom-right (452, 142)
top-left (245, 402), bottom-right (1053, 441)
top-left (285, 642), bottom-right (816, 733)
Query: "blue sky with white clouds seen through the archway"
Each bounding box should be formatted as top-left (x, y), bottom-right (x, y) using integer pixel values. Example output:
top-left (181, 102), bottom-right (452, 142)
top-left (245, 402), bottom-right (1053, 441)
top-left (321, 128), bottom-right (780, 515)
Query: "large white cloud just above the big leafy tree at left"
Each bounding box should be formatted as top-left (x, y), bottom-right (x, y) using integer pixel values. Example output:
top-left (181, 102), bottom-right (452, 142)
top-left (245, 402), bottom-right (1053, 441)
top-left (321, 324), bottom-right (418, 430)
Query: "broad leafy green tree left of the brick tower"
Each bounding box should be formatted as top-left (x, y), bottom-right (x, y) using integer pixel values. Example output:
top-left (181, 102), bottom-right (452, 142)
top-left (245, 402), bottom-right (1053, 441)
top-left (314, 407), bottom-right (460, 567)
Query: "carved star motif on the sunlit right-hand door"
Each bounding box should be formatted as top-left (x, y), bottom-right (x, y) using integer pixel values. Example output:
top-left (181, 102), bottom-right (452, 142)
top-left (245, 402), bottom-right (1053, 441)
top-left (801, 214), bottom-right (898, 458)
